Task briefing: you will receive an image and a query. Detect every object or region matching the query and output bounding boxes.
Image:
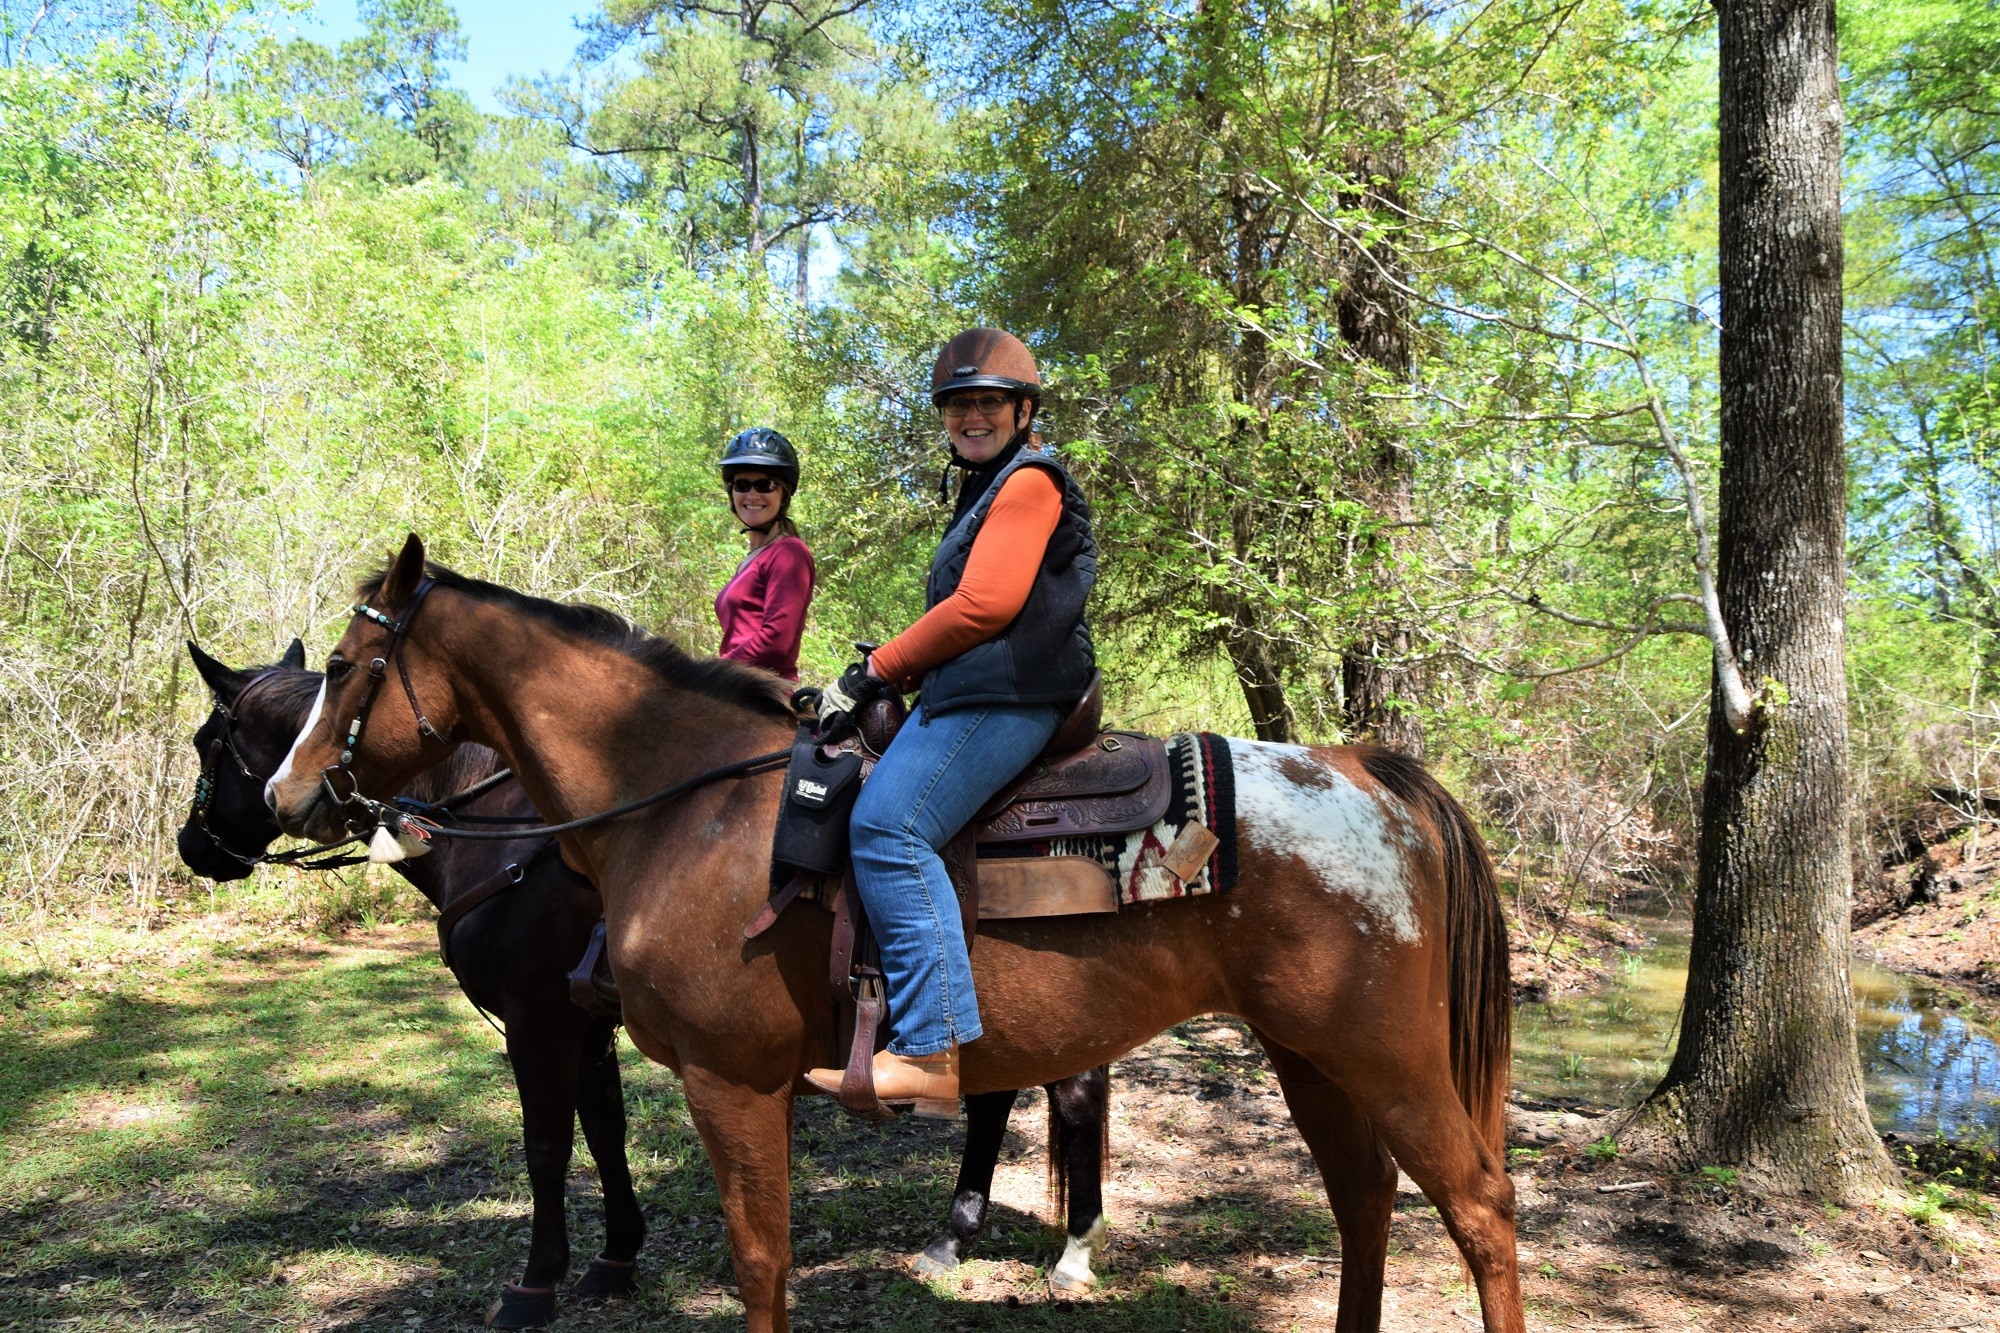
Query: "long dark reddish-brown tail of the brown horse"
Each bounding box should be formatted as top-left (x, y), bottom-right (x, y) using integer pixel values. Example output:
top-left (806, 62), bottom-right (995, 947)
top-left (1358, 747), bottom-right (1514, 1155)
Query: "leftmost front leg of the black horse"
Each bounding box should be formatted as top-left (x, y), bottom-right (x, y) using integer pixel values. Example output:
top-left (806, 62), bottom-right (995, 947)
top-left (486, 1013), bottom-right (580, 1329)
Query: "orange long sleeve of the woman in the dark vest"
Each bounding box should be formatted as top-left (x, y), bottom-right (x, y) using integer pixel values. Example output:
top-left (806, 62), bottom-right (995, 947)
top-left (868, 468), bottom-right (1062, 691)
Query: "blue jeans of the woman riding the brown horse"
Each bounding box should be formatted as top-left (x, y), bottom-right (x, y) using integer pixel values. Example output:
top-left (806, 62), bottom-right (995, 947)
top-left (848, 705), bottom-right (1062, 1055)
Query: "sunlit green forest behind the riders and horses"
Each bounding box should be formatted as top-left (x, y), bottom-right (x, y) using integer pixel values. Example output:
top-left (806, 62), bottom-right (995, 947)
top-left (0, 0), bottom-right (2000, 923)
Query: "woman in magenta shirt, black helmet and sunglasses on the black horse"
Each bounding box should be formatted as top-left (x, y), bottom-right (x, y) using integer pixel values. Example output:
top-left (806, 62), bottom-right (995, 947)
top-left (716, 426), bottom-right (812, 681)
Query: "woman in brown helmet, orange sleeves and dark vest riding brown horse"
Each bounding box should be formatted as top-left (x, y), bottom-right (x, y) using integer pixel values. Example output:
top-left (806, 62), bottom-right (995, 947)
top-left (808, 328), bottom-right (1098, 1117)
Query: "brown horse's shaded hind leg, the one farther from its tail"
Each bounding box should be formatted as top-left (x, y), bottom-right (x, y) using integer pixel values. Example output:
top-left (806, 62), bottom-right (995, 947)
top-left (1256, 1033), bottom-right (1396, 1333)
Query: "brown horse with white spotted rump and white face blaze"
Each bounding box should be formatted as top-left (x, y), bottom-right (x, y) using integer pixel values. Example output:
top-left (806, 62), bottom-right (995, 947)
top-left (266, 534), bottom-right (1526, 1333)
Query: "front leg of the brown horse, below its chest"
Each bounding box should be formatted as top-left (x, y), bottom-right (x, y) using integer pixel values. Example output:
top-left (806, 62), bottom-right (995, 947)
top-left (680, 1061), bottom-right (792, 1333)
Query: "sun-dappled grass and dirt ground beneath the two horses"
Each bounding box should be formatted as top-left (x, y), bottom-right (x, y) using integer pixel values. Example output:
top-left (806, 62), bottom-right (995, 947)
top-left (0, 908), bottom-right (2000, 1331)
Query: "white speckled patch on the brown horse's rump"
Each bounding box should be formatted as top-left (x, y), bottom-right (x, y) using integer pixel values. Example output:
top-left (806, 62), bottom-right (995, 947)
top-left (1230, 741), bottom-right (1422, 943)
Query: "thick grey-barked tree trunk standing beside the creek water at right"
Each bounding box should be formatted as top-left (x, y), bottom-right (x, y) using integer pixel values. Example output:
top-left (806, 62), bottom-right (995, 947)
top-left (1640, 0), bottom-right (1892, 1195)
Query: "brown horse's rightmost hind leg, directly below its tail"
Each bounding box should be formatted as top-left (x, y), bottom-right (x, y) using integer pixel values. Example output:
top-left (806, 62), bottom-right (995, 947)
top-left (1320, 1059), bottom-right (1528, 1333)
